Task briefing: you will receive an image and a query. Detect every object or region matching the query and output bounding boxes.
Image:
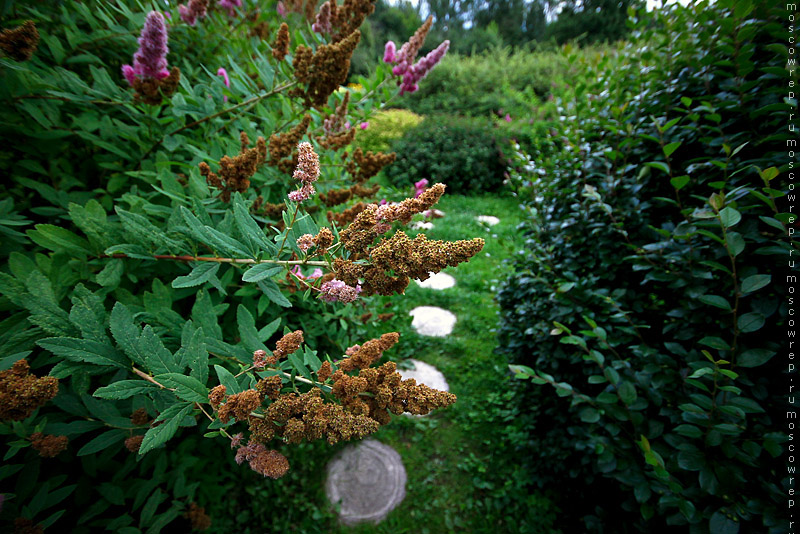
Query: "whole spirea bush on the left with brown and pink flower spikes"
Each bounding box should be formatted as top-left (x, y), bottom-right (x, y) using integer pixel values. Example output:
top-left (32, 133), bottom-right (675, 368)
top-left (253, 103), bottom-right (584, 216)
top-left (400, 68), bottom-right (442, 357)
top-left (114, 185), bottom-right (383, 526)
top-left (0, 0), bottom-right (476, 533)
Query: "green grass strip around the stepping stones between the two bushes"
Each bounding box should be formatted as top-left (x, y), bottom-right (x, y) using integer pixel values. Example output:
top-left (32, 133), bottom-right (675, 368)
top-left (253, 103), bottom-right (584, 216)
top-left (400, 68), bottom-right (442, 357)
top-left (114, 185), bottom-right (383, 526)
top-left (328, 195), bottom-right (555, 534)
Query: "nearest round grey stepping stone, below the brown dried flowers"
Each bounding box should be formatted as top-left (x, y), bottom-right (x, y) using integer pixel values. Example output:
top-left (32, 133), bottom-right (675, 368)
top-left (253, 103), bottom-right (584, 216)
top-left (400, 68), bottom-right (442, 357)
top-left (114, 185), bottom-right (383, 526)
top-left (325, 439), bottom-right (406, 525)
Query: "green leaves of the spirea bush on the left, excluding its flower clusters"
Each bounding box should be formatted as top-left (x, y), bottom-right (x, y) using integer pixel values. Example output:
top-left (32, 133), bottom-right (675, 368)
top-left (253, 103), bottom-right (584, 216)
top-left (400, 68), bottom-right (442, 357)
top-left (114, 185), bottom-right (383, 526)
top-left (0, 0), bottom-right (468, 534)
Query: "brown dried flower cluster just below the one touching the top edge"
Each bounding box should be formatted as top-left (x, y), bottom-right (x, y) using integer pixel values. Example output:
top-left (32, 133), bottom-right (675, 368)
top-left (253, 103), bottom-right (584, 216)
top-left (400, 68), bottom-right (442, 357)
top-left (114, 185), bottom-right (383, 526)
top-left (292, 30), bottom-right (361, 109)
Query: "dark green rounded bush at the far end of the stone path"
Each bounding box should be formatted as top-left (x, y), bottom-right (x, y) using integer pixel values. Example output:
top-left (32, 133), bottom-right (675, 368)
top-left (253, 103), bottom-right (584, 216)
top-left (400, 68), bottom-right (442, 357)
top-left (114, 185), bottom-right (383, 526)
top-left (384, 115), bottom-right (506, 194)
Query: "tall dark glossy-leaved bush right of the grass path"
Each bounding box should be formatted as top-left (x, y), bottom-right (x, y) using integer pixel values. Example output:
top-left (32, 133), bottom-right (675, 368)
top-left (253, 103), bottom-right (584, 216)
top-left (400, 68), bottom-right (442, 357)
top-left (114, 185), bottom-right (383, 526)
top-left (498, 2), bottom-right (796, 534)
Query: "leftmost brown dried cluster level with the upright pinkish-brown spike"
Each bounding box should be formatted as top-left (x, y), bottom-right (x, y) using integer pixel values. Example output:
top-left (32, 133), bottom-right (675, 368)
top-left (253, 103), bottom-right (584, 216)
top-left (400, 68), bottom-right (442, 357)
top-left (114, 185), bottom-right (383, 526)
top-left (198, 132), bottom-right (267, 202)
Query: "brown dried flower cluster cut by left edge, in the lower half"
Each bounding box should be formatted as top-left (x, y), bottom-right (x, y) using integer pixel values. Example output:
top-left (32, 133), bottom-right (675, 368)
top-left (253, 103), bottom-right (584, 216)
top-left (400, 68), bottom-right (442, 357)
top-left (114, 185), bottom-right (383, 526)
top-left (0, 360), bottom-right (58, 421)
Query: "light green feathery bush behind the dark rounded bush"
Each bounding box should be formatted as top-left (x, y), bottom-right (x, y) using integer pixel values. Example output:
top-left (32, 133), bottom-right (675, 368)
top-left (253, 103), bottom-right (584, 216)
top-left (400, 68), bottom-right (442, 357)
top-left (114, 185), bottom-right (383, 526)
top-left (396, 48), bottom-right (570, 117)
